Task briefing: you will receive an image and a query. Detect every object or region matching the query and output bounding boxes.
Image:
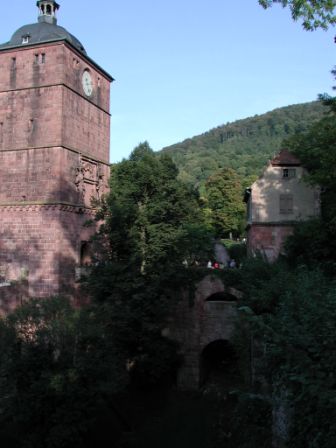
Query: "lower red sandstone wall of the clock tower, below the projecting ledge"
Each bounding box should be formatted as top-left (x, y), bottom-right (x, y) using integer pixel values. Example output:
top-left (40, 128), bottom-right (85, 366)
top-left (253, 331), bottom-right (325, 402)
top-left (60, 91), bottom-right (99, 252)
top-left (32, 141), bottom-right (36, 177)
top-left (0, 205), bottom-right (96, 304)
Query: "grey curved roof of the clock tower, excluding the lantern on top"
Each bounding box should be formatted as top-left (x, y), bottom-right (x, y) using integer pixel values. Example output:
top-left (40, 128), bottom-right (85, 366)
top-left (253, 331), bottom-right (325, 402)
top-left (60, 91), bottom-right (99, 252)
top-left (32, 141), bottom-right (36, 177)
top-left (0, 21), bottom-right (86, 55)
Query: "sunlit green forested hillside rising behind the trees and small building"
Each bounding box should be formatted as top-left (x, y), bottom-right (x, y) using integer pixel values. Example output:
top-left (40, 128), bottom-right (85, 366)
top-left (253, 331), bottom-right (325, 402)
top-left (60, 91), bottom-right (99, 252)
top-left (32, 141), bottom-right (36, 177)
top-left (162, 101), bottom-right (325, 186)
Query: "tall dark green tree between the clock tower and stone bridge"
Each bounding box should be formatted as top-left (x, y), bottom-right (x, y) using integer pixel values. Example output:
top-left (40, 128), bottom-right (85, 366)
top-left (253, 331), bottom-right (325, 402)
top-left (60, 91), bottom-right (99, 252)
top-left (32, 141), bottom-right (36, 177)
top-left (87, 143), bottom-right (213, 385)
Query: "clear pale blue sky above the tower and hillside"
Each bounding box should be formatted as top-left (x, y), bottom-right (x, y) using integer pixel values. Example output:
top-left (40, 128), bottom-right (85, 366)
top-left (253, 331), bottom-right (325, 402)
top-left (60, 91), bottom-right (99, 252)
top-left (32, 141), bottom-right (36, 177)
top-left (0, 0), bottom-right (336, 163)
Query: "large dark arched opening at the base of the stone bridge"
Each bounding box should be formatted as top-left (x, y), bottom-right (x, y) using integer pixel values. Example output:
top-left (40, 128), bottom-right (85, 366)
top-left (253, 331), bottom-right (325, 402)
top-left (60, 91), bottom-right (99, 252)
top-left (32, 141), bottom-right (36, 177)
top-left (200, 339), bottom-right (241, 389)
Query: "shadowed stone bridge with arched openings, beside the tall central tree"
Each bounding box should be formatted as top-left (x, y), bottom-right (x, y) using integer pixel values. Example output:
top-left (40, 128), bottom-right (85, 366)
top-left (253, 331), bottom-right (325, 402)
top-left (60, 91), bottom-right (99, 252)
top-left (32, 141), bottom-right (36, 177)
top-left (169, 274), bottom-right (241, 390)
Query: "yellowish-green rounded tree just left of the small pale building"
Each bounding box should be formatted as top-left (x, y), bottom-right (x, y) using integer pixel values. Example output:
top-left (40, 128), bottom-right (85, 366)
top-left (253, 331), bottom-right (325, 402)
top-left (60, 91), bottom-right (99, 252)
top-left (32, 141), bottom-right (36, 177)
top-left (205, 168), bottom-right (245, 237)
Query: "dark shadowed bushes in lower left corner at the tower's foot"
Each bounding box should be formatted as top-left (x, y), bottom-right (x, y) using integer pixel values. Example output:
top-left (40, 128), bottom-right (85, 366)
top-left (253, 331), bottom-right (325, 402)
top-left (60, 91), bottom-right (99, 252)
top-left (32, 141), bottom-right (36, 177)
top-left (0, 298), bottom-right (126, 448)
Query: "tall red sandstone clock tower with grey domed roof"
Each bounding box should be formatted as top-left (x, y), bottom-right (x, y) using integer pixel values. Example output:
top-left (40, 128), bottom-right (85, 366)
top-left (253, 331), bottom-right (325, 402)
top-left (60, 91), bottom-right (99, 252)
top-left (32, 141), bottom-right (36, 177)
top-left (0, 0), bottom-right (113, 310)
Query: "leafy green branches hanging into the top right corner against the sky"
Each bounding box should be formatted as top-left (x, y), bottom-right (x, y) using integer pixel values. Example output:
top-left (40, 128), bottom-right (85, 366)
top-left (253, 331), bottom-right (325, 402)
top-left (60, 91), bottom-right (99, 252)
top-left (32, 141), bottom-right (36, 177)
top-left (259, 0), bottom-right (336, 31)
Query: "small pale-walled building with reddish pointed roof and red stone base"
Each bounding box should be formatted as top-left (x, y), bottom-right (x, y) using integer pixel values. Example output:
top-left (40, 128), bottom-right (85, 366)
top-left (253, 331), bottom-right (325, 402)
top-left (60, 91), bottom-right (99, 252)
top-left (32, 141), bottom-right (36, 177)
top-left (245, 149), bottom-right (320, 261)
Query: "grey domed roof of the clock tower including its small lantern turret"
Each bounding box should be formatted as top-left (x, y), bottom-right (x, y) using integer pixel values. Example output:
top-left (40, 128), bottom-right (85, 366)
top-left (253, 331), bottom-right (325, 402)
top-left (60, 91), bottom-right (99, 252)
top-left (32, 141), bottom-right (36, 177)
top-left (0, 0), bottom-right (86, 55)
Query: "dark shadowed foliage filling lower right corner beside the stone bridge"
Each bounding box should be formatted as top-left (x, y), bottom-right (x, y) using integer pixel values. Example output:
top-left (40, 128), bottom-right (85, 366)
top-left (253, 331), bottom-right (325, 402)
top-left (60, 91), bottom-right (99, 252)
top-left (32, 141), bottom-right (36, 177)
top-left (225, 254), bottom-right (336, 448)
